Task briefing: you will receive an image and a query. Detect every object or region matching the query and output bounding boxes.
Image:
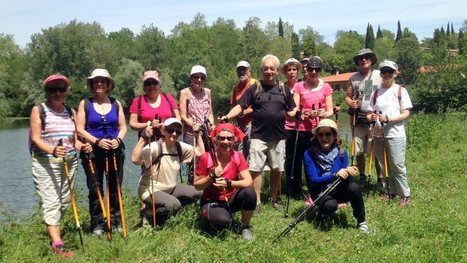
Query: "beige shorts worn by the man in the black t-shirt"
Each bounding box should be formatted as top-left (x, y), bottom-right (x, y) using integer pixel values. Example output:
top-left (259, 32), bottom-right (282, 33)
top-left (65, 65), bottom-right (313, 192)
top-left (248, 139), bottom-right (285, 172)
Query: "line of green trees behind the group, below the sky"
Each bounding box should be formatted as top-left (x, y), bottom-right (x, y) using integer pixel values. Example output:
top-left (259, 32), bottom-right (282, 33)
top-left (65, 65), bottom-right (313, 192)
top-left (0, 13), bottom-right (467, 118)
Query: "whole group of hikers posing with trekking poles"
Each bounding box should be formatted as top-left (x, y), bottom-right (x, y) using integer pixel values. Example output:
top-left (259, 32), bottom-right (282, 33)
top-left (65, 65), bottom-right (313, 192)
top-left (30, 49), bottom-right (412, 257)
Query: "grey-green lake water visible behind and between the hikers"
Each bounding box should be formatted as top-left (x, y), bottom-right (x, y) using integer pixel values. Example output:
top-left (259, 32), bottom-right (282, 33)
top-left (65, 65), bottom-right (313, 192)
top-left (0, 114), bottom-right (350, 221)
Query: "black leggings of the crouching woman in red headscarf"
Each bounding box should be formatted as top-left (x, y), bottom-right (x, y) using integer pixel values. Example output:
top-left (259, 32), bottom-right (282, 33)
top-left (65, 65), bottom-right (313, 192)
top-left (201, 186), bottom-right (256, 230)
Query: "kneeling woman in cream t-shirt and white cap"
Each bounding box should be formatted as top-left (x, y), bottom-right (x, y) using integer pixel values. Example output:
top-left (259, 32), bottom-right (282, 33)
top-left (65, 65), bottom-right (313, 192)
top-left (131, 118), bottom-right (204, 224)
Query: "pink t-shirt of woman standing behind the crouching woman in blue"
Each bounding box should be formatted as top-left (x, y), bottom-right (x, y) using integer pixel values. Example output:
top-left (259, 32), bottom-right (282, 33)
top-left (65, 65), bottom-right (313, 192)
top-left (293, 79), bottom-right (332, 131)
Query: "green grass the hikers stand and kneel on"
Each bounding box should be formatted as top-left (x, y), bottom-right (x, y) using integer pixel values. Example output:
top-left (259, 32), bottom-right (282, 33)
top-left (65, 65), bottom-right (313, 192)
top-left (0, 113), bottom-right (467, 262)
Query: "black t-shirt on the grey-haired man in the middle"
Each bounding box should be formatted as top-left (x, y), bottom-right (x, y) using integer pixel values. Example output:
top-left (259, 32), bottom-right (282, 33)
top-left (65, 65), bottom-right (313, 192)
top-left (238, 82), bottom-right (295, 141)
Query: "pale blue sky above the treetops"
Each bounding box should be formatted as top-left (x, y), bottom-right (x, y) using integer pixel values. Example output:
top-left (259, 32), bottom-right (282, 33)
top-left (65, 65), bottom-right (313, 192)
top-left (0, 0), bottom-right (467, 47)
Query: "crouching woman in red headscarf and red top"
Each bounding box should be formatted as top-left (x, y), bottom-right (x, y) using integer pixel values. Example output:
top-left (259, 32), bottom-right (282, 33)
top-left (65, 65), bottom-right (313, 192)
top-left (194, 123), bottom-right (256, 240)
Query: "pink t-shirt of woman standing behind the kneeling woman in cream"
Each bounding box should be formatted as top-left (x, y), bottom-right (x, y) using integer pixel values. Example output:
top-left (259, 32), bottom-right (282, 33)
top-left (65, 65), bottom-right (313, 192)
top-left (130, 93), bottom-right (178, 123)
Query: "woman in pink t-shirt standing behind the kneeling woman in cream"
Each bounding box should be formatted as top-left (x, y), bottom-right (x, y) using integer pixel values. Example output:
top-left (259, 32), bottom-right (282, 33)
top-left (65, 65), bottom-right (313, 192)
top-left (130, 70), bottom-right (180, 140)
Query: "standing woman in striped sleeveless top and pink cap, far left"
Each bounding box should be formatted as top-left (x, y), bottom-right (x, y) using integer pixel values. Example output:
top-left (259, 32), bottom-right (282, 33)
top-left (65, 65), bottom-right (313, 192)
top-left (30, 74), bottom-right (91, 258)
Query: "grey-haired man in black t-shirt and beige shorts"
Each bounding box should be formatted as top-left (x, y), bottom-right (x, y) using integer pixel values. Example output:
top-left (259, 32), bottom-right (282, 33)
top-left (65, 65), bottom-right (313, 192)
top-left (221, 55), bottom-right (298, 208)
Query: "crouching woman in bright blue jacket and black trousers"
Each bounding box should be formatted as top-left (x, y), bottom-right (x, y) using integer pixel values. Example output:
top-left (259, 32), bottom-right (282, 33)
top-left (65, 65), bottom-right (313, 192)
top-left (303, 119), bottom-right (368, 232)
